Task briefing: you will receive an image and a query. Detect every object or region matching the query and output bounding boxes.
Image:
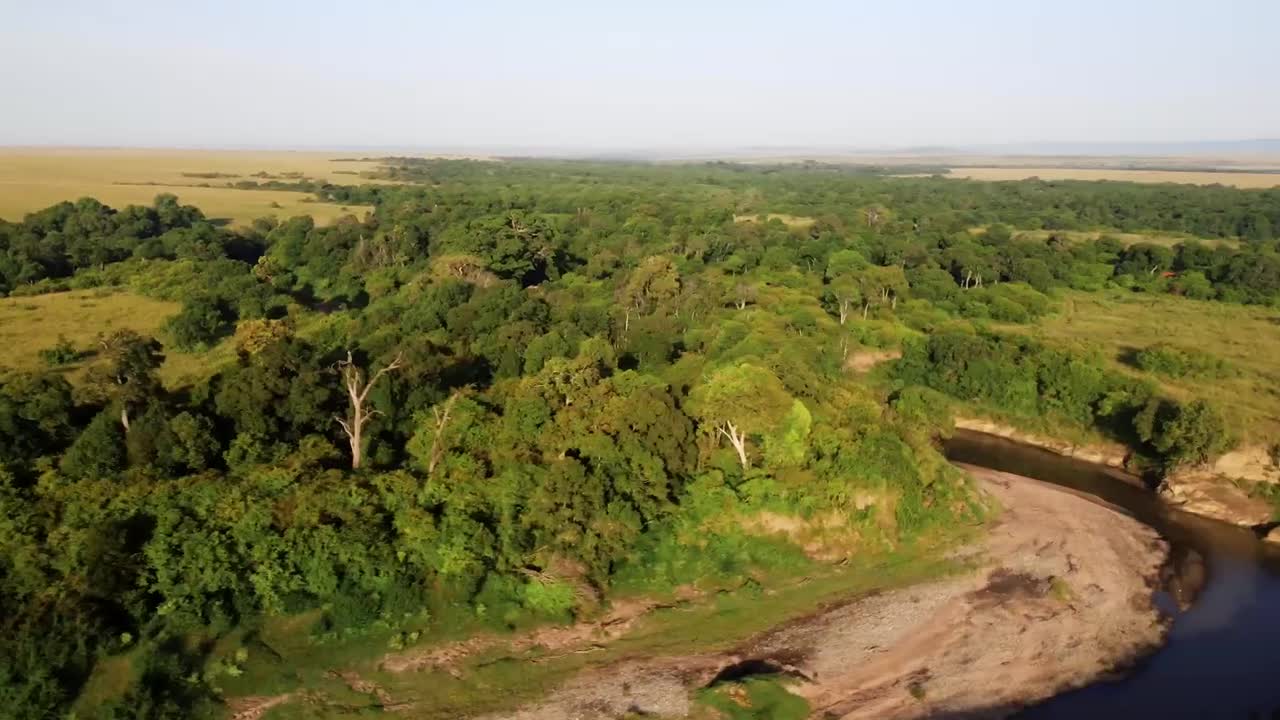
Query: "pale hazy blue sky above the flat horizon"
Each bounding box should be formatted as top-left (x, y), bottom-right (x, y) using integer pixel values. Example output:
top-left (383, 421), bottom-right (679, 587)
top-left (0, 0), bottom-right (1280, 151)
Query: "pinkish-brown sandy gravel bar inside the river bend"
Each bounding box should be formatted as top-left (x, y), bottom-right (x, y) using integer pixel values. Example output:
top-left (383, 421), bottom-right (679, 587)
top-left (478, 468), bottom-right (1167, 720)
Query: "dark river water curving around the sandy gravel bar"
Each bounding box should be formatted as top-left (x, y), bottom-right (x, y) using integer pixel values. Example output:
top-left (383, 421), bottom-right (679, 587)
top-left (946, 432), bottom-right (1280, 720)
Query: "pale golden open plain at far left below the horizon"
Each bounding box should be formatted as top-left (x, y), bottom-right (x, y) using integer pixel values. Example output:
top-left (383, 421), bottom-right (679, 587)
top-left (0, 147), bottom-right (378, 224)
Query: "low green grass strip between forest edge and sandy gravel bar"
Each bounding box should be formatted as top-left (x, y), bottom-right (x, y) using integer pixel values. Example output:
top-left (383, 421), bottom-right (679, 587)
top-left (215, 528), bottom-right (973, 720)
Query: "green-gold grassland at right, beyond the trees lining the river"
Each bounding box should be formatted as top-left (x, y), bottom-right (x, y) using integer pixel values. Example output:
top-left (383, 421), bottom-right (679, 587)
top-left (1002, 290), bottom-right (1280, 443)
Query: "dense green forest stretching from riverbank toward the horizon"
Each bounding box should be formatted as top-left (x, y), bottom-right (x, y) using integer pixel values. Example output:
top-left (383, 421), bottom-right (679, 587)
top-left (0, 158), bottom-right (1280, 717)
